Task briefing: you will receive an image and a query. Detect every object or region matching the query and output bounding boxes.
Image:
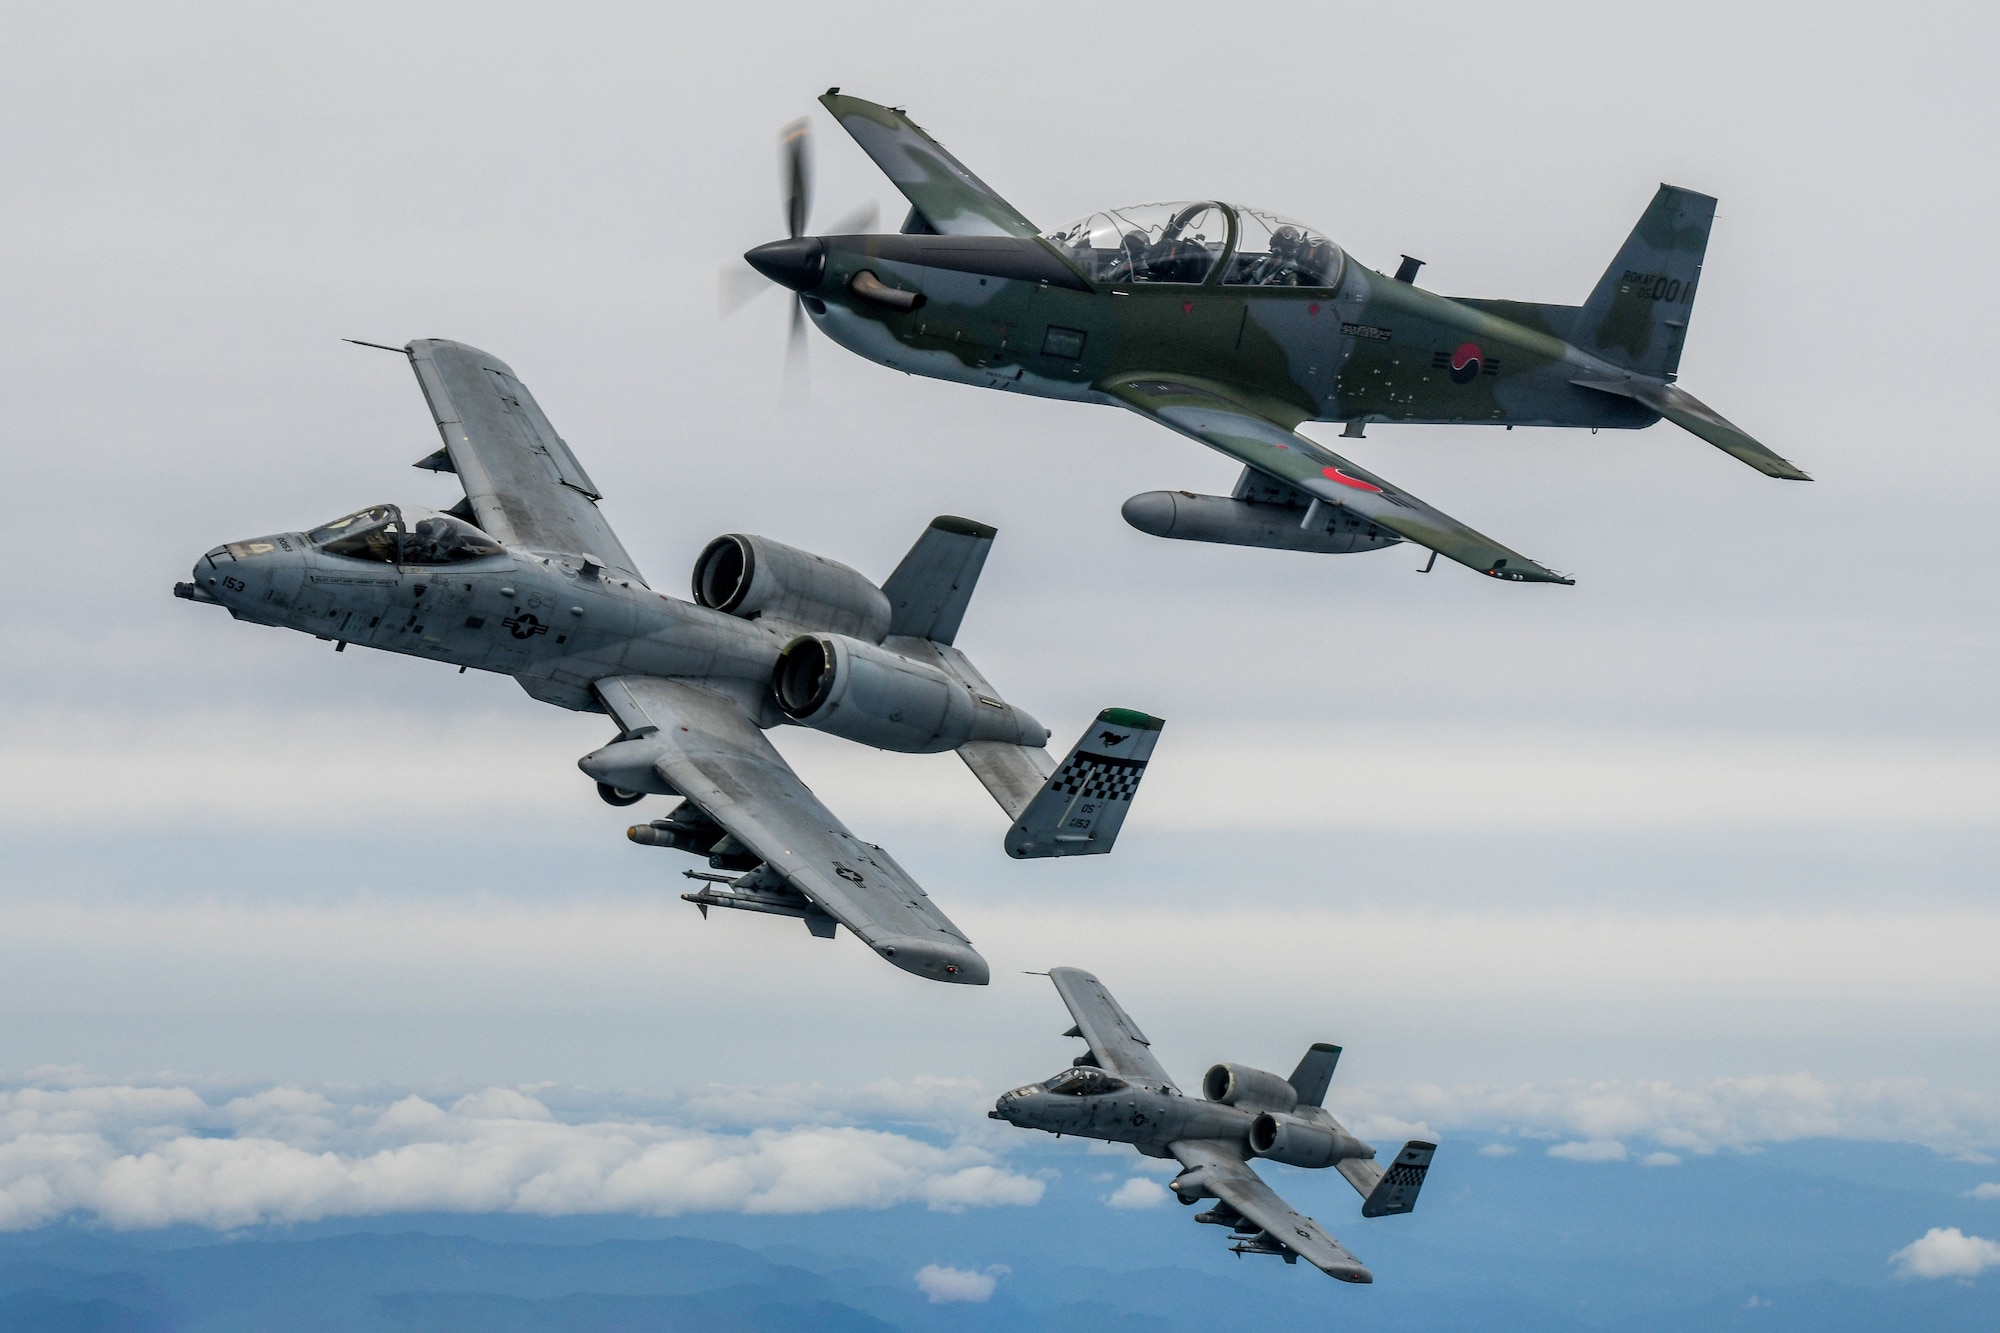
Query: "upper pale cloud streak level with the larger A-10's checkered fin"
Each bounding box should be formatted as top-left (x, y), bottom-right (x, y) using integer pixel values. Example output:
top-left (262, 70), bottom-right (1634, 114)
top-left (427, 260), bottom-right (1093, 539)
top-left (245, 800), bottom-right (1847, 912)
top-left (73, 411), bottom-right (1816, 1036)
top-left (0, 704), bottom-right (2000, 833)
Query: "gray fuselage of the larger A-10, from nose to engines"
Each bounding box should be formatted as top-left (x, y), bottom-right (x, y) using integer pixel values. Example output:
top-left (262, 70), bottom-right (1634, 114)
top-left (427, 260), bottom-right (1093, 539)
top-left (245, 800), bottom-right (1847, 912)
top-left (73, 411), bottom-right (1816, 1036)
top-left (194, 532), bottom-right (794, 727)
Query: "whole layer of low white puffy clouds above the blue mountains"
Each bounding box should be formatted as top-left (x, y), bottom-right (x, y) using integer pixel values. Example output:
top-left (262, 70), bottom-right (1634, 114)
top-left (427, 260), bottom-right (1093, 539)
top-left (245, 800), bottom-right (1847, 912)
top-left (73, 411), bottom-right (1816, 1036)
top-left (11, 1069), bottom-right (2000, 1232)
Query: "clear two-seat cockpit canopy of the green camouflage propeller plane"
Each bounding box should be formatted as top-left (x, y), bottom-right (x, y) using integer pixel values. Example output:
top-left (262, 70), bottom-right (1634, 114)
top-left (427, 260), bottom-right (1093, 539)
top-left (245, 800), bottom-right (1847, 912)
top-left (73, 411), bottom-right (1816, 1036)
top-left (1044, 200), bottom-right (1346, 286)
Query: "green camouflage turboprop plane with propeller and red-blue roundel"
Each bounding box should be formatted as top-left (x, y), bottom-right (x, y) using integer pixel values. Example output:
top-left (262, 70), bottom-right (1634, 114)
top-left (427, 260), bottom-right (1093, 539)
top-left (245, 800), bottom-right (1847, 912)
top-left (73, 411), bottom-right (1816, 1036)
top-left (744, 88), bottom-right (1810, 582)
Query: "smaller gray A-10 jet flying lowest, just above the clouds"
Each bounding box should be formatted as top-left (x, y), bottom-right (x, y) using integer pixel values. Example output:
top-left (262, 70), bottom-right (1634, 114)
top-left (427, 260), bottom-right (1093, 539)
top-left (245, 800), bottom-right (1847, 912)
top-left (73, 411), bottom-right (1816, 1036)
top-left (988, 967), bottom-right (1438, 1283)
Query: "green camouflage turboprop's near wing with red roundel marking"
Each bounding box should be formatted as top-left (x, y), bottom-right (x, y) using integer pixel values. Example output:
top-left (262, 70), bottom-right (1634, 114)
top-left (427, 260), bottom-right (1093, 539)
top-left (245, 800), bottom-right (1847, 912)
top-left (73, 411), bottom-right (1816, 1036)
top-left (1098, 374), bottom-right (1576, 582)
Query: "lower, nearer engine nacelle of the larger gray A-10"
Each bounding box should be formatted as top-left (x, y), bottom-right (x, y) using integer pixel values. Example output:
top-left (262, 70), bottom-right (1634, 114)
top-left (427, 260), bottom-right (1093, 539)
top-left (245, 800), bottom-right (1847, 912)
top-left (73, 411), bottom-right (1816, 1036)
top-left (770, 634), bottom-right (1048, 755)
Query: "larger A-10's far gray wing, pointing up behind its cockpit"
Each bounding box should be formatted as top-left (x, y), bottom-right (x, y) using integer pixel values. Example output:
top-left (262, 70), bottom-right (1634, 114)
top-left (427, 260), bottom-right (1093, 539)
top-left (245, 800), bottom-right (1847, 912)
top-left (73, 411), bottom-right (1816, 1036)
top-left (404, 338), bottom-right (644, 582)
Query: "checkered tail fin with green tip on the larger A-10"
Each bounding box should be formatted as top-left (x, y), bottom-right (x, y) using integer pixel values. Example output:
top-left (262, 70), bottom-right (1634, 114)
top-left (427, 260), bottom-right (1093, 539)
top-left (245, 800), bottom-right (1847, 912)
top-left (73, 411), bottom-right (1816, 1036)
top-left (1008, 709), bottom-right (1164, 861)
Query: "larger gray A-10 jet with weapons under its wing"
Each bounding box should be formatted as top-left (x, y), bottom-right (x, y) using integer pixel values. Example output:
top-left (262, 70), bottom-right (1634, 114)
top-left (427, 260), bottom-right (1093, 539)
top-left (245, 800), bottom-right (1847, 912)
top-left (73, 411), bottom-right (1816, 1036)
top-left (174, 338), bottom-right (1160, 985)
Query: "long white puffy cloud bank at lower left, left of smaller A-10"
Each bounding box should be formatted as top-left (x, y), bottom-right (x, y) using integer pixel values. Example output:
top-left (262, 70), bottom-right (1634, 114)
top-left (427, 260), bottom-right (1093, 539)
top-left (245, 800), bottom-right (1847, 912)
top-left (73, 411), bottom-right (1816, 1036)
top-left (0, 1081), bottom-right (1044, 1229)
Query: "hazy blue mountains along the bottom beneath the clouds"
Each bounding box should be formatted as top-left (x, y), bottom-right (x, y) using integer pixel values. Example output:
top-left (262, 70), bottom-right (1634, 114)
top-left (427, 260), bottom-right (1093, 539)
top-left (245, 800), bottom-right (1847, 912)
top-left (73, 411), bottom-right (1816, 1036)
top-left (0, 1141), bottom-right (2000, 1333)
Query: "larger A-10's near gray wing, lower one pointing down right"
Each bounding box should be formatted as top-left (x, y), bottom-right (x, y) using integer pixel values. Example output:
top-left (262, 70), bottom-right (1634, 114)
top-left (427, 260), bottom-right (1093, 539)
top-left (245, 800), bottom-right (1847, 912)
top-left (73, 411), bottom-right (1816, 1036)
top-left (596, 677), bottom-right (988, 985)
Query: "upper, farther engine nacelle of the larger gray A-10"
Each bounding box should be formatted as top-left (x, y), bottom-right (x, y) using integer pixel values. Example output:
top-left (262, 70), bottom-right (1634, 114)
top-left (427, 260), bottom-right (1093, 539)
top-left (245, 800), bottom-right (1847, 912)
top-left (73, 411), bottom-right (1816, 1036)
top-left (694, 532), bottom-right (894, 642)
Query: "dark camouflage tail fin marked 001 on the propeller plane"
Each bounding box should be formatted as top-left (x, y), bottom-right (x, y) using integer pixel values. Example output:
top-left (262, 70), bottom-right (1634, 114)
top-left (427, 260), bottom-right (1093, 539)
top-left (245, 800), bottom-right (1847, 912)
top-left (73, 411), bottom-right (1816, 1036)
top-left (1570, 184), bottom-right (1716, 380)
